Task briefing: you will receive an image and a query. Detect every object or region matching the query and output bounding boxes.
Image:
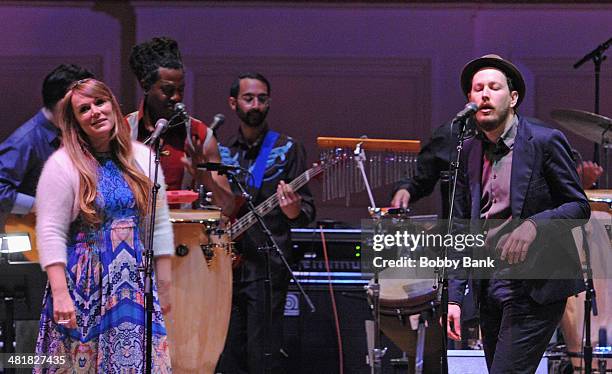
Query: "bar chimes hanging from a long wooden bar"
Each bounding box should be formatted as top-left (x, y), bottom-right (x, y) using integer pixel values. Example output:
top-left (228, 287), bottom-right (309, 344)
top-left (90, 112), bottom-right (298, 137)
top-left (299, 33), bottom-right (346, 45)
top-left (317, 137), bottom-right (421, 206)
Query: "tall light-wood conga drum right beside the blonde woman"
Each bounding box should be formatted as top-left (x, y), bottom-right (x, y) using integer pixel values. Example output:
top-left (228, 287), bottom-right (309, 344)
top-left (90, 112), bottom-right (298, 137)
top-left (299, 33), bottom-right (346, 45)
top-left (166, 210), bottom-right (232, 373)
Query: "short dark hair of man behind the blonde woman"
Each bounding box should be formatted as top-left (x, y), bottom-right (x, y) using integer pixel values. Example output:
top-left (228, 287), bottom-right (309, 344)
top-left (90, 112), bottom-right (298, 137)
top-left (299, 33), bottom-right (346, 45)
top-left (42, 64), bottom-right (94, 110)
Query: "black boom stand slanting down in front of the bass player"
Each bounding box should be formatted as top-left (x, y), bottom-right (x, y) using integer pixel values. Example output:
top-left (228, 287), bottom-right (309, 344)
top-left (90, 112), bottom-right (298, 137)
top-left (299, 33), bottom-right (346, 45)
top-left (226, 170), bottom-right (316, 374)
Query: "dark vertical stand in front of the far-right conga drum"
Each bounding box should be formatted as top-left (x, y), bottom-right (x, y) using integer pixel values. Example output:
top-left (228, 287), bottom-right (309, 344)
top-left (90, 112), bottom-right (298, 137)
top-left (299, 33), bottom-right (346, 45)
top-left (581, 226), bottom-right (597, 374)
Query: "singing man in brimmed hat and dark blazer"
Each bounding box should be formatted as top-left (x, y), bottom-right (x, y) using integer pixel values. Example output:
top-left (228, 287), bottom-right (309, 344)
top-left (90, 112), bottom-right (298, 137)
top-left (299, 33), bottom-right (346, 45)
top-left (448, 55), bottom-right (590, 373)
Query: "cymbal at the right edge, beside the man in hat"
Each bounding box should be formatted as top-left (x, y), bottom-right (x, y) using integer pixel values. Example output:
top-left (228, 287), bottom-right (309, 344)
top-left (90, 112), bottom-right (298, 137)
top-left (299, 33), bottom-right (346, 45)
top-left (550, 109), bottom-right (612, 144)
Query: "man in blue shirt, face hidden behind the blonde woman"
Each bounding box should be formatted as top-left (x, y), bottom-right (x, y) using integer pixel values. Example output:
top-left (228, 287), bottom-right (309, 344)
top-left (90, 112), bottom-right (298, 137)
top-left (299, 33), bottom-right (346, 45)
top-left (0, 65), bottom-right (93, 352)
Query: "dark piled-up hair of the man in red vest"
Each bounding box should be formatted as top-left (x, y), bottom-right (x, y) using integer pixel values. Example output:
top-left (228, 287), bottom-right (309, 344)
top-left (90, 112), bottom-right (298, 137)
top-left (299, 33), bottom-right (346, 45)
top-left (130, 37), bottom-right (183, 90)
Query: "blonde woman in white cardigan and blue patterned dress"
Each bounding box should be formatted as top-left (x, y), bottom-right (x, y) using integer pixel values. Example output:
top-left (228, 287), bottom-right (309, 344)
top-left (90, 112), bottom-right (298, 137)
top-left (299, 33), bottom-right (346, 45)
top-left (35, 79), bottom-right (173, 373)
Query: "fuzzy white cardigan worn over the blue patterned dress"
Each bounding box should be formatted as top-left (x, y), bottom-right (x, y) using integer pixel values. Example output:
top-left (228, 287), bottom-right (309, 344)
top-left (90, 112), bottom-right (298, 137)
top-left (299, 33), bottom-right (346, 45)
top-left (35, 142), bottom-right (174, 269)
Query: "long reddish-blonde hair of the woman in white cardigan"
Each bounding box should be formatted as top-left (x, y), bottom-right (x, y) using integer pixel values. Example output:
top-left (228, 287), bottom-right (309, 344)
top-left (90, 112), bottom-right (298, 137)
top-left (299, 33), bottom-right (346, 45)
top-left (58, 78), bottom-right (152, 224)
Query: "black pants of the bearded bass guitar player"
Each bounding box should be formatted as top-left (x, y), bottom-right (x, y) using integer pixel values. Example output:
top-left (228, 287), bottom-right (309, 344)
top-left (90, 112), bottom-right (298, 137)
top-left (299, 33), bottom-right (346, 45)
top-left (216, 277), bottom-right (289, 374)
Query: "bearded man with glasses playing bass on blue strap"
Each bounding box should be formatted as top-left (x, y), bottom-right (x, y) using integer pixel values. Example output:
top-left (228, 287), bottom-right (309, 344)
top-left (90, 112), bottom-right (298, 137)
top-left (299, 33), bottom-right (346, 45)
top-left (217, 73), bottom-right (315, 374)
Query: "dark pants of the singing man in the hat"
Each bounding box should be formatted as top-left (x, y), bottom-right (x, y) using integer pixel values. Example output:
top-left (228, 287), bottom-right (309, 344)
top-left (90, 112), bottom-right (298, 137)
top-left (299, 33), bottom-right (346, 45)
top-left (480, 284), bottom-right (565, 374)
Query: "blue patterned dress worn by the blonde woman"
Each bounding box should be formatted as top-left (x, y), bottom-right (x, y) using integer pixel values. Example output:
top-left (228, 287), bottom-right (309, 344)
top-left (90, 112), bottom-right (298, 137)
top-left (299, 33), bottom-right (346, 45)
top-left (34, 156), bottom-right (172, 374)
